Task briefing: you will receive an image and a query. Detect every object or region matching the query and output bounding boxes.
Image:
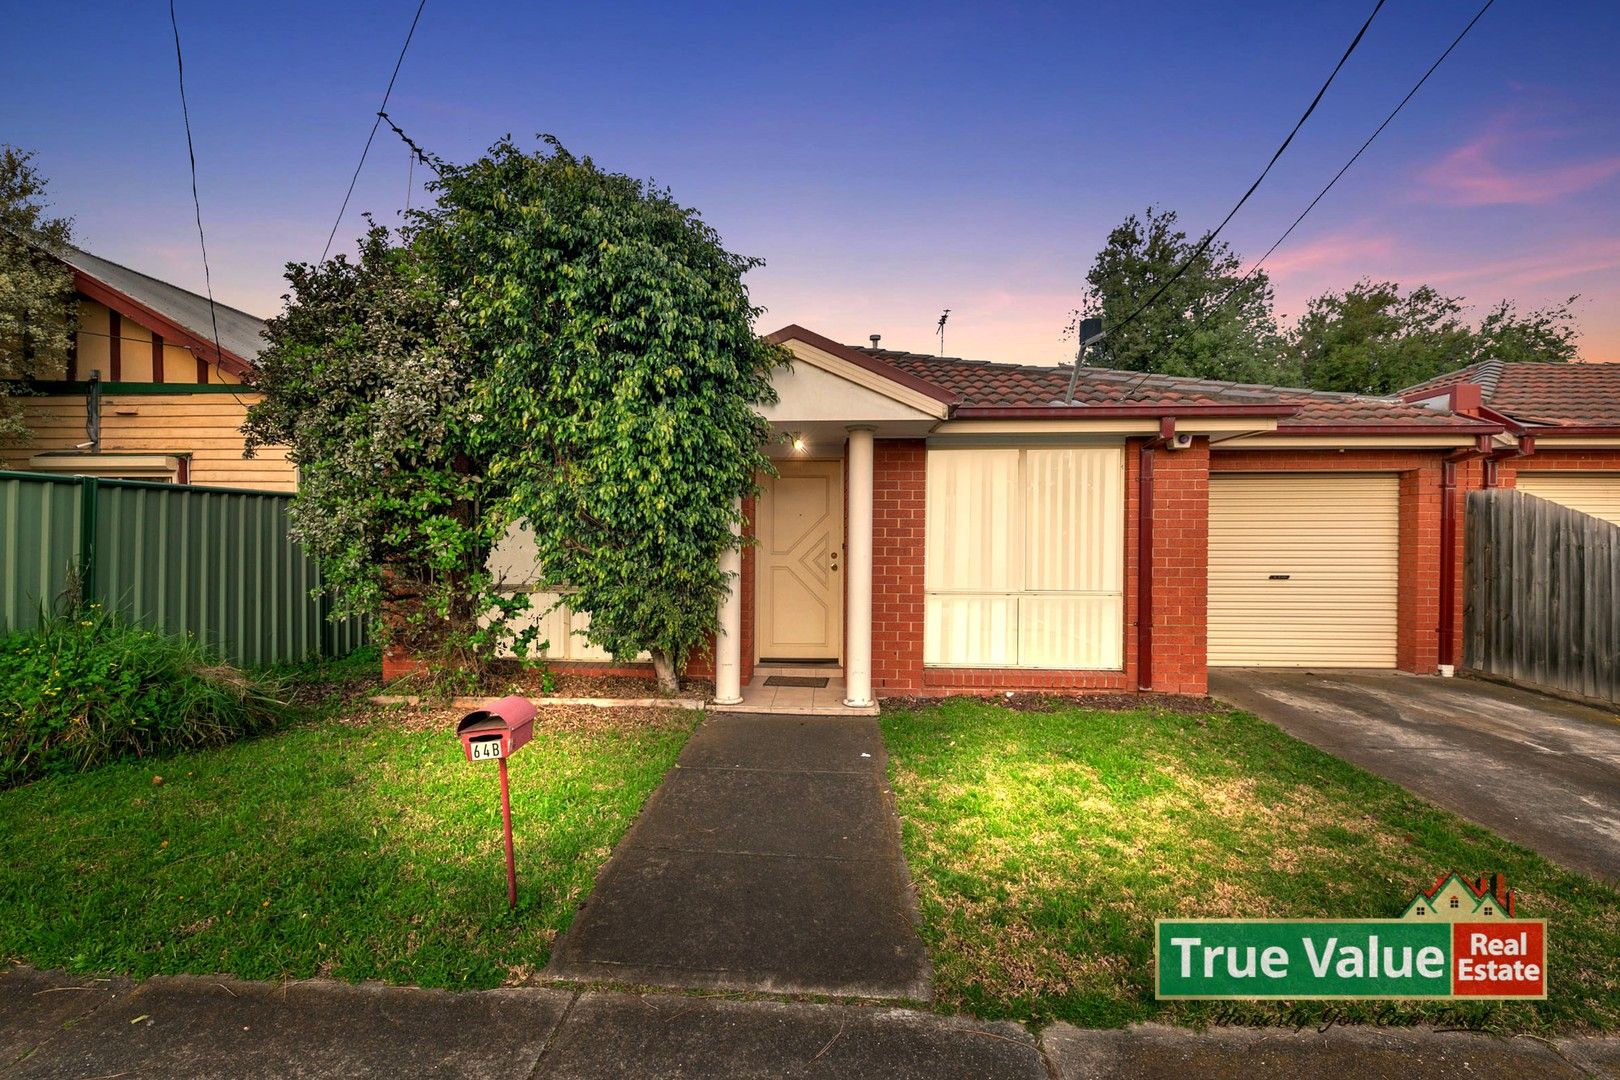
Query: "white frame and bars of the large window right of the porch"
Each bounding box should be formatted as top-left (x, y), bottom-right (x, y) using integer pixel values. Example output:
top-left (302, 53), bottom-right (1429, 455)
top-left (923, 444), bottom-right (1126, 672)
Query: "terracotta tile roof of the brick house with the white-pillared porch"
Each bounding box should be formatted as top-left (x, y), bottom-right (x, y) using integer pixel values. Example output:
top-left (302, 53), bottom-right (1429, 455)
top-left (859, 348), bottom-right (1479, 429)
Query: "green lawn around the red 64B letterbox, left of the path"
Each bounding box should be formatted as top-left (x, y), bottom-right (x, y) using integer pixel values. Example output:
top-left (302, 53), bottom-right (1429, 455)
top-left (0, 706), bottom-right (698, 988)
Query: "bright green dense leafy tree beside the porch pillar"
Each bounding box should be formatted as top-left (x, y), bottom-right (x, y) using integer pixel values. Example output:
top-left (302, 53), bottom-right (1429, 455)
top-left (423, 139), bottom-right (786, 690)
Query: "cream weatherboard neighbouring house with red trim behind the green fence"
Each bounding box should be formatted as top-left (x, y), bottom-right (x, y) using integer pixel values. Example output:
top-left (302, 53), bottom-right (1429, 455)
top-left (0, 248), bottom-right (298, 491)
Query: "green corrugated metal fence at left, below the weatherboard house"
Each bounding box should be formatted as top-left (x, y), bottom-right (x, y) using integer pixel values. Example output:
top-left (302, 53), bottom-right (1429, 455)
top-left (0, 471), bottom-right (366, 667)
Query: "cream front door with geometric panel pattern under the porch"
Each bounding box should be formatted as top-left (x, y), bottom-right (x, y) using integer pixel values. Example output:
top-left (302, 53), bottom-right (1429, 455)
top-left (755, 461), bottom-right (844, 661)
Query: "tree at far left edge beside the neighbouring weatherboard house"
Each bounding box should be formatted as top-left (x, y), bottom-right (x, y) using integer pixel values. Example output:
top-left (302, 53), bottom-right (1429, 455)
top-left (0, 144), bottom-right (78, 437)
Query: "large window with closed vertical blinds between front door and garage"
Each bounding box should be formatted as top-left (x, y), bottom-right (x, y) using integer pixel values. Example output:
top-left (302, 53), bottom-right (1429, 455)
top-left (923, 447), bottom-right (1124, 670)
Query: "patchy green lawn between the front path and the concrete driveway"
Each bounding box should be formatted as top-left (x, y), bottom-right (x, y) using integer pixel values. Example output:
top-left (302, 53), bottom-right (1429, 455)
top-left (883, 699), bottom-right (1620, 1033)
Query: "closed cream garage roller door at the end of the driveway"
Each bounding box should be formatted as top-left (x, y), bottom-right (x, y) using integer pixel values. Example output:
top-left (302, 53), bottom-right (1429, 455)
top-left (1209, 474), bottom-right (1400, 667)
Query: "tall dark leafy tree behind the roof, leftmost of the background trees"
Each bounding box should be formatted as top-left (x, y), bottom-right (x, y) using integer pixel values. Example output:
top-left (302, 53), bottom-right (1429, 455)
top-left (1079, 207), bottom-right (1283, 384)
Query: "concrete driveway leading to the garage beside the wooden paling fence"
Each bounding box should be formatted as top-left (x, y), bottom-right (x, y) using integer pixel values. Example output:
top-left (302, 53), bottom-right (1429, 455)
top-left (1210, 669), bottom-right (1620, 881)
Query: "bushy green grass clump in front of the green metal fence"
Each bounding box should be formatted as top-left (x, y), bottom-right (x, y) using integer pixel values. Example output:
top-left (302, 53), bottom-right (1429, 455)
top-left (0, 606), bottom-right (288, 787)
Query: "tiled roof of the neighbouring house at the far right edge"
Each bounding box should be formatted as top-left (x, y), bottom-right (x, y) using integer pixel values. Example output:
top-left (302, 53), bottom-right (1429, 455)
top-left (1401, 359), bottom-right (1620, 427)
